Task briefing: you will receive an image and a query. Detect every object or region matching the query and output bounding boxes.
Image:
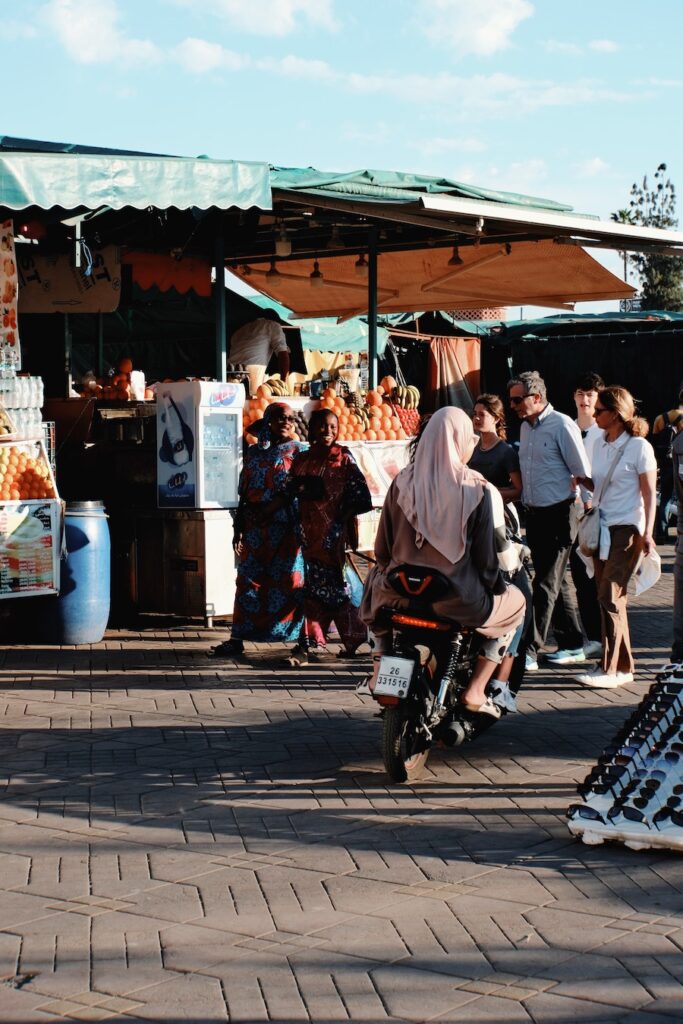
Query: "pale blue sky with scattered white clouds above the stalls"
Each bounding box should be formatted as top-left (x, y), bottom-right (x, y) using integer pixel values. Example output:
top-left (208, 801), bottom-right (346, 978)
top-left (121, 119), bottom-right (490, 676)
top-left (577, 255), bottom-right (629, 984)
top-left (5, 0), bottom-right (683, 315)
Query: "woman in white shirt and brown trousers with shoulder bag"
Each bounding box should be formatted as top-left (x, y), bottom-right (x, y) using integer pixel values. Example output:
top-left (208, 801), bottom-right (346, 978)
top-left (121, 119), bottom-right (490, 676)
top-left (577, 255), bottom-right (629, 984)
top-left (577, 387), bottom-right (656, 689)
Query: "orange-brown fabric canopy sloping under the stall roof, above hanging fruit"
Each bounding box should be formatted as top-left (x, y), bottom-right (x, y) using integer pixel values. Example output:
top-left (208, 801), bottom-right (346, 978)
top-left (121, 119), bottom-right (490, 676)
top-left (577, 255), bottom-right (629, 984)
top-left (232, 240), bottom-right (634, 317)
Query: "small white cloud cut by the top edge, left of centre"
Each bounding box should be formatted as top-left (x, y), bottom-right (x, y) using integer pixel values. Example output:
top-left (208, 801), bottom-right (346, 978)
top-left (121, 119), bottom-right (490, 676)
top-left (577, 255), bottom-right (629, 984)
top-left (175, 0), bottom-right (338, 36)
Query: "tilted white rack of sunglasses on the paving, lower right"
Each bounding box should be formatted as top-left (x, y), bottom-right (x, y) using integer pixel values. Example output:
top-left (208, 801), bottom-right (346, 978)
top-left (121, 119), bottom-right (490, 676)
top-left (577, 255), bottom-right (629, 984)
top-left (567, 662), bottom-right (683, 850)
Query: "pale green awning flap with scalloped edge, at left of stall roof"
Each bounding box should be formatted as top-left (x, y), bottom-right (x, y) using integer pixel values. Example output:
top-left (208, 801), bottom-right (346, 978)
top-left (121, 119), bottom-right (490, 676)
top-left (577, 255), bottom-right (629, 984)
top-left (0, 152), bottom-right (272, 211)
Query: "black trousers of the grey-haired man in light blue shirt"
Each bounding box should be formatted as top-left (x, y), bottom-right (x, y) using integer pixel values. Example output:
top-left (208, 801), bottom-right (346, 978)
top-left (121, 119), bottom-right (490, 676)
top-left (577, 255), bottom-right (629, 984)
top-left (526, 498), bottom-right (584, 654)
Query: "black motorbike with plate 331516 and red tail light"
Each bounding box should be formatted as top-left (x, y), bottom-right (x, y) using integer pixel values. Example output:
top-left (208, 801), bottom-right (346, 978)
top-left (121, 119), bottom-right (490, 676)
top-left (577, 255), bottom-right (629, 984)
top-left (372, 565), bottom-right (505, 782)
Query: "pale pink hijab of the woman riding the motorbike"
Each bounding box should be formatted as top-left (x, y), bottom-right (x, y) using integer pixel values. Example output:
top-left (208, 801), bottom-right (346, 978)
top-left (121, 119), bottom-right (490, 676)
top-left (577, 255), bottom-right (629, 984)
top-left (395, 407), bottom-right (486, 565)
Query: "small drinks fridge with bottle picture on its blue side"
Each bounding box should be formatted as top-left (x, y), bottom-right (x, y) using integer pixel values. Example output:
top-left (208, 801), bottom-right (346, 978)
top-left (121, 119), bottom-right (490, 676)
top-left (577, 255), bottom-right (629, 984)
top-left (157, 381), bottom-right (245, 509)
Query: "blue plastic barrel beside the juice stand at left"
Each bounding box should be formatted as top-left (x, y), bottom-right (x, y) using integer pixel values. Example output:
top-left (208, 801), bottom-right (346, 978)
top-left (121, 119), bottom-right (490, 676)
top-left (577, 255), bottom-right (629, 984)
top-left (37, 502), bottom-right (111, 644)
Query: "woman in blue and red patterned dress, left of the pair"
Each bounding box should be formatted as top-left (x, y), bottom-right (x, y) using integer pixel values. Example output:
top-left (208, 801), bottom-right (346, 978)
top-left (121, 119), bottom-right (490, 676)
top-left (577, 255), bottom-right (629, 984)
top-left (208, 402), bottom-right (307, 657)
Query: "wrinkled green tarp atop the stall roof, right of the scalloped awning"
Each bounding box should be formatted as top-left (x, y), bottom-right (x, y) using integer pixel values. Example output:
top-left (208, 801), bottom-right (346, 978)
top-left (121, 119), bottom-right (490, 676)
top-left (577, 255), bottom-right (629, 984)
top-left (270, 167), bottom-right (572, 213)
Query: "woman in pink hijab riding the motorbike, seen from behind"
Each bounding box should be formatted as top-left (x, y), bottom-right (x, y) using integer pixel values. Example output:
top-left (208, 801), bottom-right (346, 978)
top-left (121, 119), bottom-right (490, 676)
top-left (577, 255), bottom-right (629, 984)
top-left (360, 408), bottom-right (524, 717)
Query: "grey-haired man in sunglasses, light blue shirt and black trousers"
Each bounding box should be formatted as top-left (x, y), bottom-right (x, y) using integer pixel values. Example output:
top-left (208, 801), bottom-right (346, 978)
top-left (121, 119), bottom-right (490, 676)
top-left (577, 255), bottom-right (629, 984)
top-left (508, 370), bottom-right (593, 672)
